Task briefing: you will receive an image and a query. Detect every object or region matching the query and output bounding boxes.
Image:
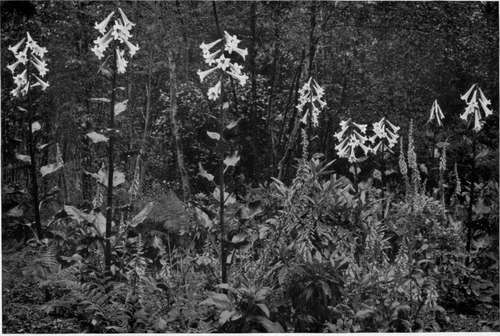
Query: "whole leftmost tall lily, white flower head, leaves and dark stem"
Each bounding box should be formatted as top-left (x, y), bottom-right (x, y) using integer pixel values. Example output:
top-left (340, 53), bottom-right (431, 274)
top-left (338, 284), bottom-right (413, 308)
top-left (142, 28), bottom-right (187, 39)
top-left (7, 32), bottom-right (49, 238)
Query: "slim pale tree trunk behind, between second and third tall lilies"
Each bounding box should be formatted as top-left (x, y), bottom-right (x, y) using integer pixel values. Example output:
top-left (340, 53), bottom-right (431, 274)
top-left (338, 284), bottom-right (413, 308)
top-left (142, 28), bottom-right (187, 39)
top-left (168, 50), bottom-right (191, 201)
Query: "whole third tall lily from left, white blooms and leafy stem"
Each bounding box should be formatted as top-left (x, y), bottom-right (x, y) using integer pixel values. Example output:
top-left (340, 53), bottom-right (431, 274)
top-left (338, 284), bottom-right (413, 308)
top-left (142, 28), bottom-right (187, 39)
top-left (197, 31), bottom-right (248, 283)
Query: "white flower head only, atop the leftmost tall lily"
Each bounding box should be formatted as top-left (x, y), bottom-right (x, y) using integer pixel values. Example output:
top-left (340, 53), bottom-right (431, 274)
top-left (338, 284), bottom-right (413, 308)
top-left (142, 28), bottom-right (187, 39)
top-left (7, 33), bottom-right (49, 97)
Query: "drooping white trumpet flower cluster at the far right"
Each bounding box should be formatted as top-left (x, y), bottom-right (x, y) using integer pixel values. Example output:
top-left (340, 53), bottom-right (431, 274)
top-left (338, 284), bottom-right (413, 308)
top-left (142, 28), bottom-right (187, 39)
top-left (460, 84), bottom-right (493, 132)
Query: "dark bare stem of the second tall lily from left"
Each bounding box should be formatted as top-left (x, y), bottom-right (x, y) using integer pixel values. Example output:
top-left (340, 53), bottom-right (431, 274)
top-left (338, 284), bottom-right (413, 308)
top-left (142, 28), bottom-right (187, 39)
top-left (104, 50), bottom-right (116, 273)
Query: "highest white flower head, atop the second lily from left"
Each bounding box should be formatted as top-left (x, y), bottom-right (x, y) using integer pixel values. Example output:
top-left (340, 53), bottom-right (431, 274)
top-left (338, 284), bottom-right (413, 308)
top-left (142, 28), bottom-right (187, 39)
top-left (92, 8), bottom-right (139, 74)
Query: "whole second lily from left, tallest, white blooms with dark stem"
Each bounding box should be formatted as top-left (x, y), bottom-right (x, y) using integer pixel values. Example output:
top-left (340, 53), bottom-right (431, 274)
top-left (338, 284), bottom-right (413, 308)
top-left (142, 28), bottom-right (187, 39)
top-left (92, 8), bottom-right (139, 272)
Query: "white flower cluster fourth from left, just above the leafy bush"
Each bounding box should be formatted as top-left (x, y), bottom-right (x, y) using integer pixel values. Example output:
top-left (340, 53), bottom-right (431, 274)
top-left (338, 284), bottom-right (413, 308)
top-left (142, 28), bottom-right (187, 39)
top-left (297, 77), bottom-right (326, 127)
